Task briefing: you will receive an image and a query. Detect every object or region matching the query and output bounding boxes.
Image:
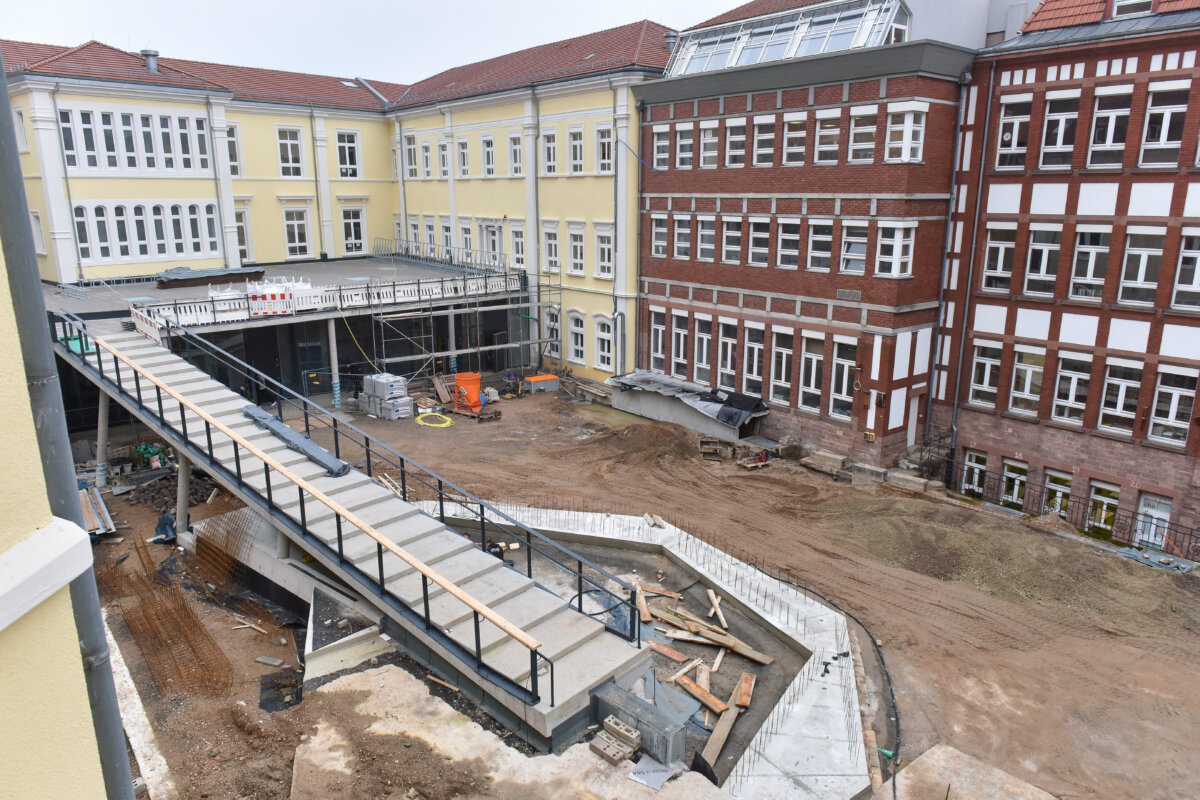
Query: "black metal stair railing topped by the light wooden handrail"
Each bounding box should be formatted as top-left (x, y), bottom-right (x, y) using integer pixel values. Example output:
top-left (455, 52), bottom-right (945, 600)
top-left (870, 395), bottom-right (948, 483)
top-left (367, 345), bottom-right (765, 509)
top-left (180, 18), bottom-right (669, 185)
top-left (50, 313), bottom-right (571, 706)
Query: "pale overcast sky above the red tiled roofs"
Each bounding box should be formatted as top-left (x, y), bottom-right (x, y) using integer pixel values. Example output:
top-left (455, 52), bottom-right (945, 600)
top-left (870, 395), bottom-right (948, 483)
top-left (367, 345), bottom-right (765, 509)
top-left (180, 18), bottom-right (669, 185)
top-left (0, 0), bottom-right (740, 83)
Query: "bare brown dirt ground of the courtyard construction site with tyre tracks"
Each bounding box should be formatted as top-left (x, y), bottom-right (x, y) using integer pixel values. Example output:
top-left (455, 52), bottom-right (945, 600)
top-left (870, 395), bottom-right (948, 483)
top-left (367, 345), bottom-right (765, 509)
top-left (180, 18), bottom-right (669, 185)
top-left (100, 396), bottom-right (1200, 800)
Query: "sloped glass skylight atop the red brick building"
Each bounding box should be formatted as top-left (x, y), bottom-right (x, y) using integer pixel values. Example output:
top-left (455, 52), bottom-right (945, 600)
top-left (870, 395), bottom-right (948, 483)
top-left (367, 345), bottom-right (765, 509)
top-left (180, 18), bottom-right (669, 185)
top-left (667, 0), bottom-right (910, 77)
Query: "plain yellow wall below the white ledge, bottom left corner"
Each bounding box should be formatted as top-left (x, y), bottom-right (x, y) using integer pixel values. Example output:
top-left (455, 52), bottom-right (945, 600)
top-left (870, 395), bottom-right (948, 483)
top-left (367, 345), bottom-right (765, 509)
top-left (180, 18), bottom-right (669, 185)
top-left (0, 585), bottom-right (104, 800)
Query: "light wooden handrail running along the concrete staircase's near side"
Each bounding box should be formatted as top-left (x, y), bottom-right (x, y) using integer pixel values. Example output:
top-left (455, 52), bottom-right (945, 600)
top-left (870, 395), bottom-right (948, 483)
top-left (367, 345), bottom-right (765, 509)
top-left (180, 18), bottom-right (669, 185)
top-left (93, 338), bottom-right (541, 650)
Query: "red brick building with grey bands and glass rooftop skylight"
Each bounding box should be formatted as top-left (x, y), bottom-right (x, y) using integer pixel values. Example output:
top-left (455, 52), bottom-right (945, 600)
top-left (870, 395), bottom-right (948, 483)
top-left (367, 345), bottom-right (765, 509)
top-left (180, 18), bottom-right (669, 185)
top-left (635, 0), bottom-right (988, 465)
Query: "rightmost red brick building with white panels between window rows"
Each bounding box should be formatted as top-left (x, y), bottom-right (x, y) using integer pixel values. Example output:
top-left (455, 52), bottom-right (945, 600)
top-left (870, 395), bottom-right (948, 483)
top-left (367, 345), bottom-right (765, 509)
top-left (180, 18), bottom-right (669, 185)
top-left (935, 0), bottom-right (1200, 558)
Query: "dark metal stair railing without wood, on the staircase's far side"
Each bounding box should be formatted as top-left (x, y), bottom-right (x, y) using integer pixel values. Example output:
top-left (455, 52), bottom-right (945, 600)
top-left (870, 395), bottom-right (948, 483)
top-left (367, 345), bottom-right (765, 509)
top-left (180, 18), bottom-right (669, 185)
top-left (109, 321), bottom-right (641, 644)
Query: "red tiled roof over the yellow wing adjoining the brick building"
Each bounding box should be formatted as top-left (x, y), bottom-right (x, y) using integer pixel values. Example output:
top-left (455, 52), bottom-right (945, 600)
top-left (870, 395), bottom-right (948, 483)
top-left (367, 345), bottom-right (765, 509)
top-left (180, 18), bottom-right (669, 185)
top-left (392, 20), bottom-right (672, 107)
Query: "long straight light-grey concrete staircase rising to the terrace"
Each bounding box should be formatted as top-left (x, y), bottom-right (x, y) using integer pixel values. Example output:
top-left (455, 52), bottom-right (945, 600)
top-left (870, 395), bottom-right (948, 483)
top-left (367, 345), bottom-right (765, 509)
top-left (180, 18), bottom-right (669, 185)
top-left (65, 330), bottom-right (649, 741)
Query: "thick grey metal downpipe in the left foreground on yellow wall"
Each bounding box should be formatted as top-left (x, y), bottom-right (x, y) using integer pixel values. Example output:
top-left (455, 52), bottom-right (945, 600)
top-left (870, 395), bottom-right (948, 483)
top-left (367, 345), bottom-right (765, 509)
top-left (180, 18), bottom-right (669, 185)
top-left (0, 48), bottom-right (133, 800)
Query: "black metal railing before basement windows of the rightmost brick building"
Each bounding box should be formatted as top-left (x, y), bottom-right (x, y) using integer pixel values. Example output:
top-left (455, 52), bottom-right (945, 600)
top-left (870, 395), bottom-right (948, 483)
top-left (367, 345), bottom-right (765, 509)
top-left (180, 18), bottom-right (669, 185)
top-left (923, 458), bottom-right (1200, 559)
